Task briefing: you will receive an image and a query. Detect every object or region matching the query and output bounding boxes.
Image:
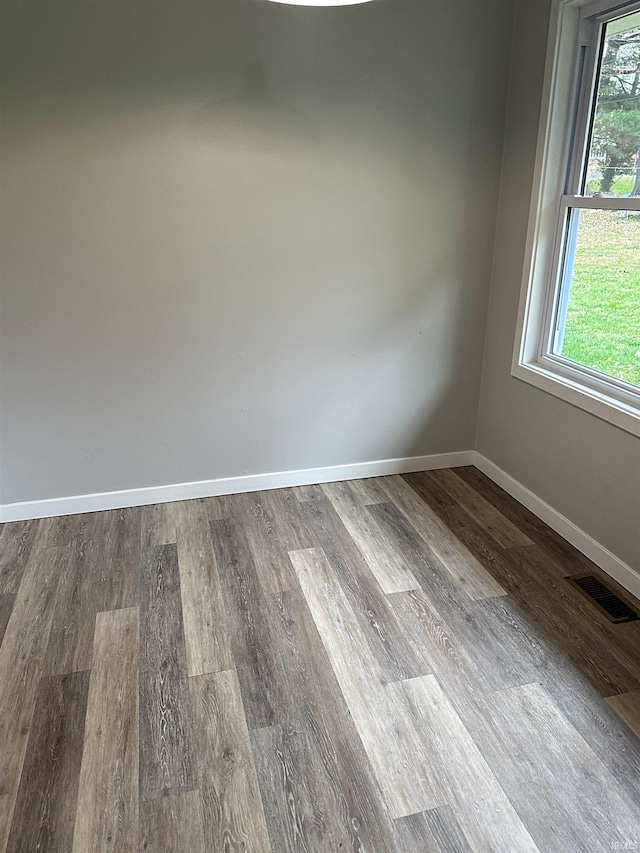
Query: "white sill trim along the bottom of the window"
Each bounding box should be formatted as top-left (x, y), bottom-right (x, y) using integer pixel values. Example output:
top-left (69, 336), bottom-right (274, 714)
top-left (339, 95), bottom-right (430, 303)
top-left (511, 363), bottom-right (640, 437)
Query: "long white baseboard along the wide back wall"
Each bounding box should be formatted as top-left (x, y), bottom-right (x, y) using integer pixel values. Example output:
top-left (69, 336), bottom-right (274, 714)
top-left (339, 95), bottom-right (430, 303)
top-left (0, 450), bottom-right (474, 522)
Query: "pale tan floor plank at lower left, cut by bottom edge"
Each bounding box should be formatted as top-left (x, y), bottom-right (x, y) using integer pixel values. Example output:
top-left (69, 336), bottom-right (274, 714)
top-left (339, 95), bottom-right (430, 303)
top-left (73, 608), bottom-right (139, 853)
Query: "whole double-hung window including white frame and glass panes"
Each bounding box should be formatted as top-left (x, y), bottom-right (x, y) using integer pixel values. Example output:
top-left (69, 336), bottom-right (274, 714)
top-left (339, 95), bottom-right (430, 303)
top-left (512, 0), bottom-right (640, 435)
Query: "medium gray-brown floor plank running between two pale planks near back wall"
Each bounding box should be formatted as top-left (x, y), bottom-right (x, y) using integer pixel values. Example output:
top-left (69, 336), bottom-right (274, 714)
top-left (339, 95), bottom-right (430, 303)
top-left (302, 500), bottom-right (431, 681)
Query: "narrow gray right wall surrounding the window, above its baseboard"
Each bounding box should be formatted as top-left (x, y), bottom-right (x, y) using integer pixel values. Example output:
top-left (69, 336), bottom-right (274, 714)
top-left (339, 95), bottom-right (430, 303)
top-left (477, 0), bottom-right (640, 570)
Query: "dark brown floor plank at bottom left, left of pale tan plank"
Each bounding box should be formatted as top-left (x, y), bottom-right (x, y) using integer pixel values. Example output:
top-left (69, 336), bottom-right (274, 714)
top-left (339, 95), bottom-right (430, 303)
top-left (7, 672), bottom-right (89, 853)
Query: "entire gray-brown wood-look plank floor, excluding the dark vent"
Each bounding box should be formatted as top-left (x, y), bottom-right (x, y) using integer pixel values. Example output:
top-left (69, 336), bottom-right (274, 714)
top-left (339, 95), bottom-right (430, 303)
top-left (0, 468), bottom-right (640, 853)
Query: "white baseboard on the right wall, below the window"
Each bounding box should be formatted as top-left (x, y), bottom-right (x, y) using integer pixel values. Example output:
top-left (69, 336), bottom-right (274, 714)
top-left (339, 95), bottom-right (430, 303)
top-left (473, 451), bottom-right (640, 599)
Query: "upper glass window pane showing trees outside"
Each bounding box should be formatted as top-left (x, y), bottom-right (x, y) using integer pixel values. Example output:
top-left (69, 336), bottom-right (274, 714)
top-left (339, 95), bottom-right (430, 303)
top-left (582, 12), bottom-right (640, 197)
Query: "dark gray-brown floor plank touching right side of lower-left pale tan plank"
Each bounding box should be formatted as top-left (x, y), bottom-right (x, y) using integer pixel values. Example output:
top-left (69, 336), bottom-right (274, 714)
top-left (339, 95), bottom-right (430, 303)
top-left (140, 545), bottom-right (194, 799)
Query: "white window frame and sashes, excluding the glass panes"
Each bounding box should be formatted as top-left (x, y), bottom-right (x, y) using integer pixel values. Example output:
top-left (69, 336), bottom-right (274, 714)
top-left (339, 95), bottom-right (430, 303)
top-left (511, 0), bottom-right (640, 436)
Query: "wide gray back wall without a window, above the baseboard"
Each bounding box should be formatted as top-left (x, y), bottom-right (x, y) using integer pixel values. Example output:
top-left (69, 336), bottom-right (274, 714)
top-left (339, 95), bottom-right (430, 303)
top-left (0, 0), bottom-right (512, 503)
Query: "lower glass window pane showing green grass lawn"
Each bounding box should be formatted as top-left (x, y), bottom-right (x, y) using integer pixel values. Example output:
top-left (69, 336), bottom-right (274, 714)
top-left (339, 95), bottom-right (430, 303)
top-left (553, 209), bottom-right (640, 387)
